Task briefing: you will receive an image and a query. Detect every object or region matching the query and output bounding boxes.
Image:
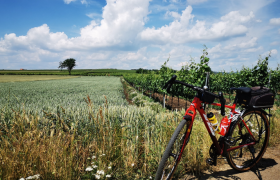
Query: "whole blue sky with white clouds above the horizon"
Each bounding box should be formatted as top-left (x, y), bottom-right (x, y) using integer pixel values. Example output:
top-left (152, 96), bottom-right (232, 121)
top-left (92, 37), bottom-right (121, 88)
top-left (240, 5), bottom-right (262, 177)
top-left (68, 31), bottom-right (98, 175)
top-left (0, 0), bottom-right (280, 72)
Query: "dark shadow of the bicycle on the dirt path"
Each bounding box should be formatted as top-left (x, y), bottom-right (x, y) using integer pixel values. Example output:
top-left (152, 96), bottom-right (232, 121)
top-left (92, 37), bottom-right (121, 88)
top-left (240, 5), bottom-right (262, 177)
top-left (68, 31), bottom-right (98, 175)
top-left (184, 158), bottom-right (278, 180)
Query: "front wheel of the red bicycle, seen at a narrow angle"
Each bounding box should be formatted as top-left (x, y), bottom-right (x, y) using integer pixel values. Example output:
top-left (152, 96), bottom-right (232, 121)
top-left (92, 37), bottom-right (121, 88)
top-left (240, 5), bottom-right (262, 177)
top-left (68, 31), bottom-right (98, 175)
top-left (155, 119), bottom-right (191, 180)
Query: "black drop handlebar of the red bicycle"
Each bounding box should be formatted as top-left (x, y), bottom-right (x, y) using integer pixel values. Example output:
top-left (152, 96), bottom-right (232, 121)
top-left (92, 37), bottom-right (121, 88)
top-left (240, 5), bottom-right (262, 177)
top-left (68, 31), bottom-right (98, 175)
top-left (162, 75), bottom-right (226, 116)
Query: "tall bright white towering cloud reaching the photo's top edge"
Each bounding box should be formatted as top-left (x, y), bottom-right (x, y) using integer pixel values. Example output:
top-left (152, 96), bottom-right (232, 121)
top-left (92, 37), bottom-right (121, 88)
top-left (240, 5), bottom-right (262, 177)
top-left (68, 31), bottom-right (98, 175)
top-left (75, 0), bottom-right (149, 47)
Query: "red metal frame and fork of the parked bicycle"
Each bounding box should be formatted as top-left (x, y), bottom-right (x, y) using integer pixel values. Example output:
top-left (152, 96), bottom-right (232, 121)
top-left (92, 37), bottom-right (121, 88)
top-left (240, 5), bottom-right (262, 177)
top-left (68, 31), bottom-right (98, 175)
top-left (180, 97), bottom-right (256, 155)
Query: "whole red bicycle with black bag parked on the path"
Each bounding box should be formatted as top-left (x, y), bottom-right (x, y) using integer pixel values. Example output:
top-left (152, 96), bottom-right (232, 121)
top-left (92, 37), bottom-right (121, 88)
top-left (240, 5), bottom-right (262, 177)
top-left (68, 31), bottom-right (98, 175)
top-left (155, 73), bottom-right (274, 180)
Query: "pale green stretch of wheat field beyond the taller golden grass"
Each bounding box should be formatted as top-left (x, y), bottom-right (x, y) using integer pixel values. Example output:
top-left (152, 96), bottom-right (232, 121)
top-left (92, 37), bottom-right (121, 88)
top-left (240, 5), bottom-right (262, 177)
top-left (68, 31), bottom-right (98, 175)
top-left (0, 76), bottom-right (127, 116)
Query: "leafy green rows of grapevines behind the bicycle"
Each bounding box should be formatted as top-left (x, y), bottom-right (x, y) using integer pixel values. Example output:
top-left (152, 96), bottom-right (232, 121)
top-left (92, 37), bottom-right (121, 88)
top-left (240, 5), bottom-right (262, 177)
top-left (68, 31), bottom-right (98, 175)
top-left (123, 50), bottom-right (280, 106)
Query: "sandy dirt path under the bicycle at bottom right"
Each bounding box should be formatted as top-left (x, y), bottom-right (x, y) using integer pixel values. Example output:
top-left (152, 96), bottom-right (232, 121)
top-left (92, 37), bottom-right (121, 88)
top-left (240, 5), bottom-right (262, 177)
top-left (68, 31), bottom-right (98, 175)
top-left (183, 145), bottom-right (280, 180)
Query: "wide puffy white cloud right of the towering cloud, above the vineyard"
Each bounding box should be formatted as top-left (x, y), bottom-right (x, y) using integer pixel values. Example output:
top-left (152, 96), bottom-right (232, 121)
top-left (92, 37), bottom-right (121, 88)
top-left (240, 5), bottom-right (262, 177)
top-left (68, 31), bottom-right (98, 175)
top-left (140, 6), bottom-right (254, 44)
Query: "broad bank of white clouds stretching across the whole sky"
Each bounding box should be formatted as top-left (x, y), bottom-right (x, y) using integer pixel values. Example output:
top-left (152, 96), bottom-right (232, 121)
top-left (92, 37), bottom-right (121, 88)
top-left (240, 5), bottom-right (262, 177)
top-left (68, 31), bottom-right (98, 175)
top-left (0, 0), bottom-right (280, 70)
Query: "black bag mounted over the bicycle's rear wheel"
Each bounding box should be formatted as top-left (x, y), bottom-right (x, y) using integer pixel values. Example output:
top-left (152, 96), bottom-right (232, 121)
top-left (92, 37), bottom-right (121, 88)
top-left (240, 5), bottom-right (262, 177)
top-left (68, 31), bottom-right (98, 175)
top-left (236, 86), bottom-right (275, 108)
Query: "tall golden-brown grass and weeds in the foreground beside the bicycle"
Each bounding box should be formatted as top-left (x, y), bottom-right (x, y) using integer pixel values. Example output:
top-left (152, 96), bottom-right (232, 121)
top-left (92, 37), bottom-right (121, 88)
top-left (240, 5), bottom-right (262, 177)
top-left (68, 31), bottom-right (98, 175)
top-left (0, 97), bottom-right (212, 179)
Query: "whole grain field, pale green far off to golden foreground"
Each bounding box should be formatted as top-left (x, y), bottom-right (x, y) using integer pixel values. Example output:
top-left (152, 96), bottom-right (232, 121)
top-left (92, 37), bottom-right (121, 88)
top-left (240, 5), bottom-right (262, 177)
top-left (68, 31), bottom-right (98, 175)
top-left (0, 77), bottom-right (280, 179)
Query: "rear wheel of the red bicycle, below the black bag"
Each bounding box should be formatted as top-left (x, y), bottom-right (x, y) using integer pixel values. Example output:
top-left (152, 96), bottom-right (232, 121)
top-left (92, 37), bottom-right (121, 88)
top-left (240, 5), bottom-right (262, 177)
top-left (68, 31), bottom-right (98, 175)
top-left (225, 109), bottom-right (269, 172)
